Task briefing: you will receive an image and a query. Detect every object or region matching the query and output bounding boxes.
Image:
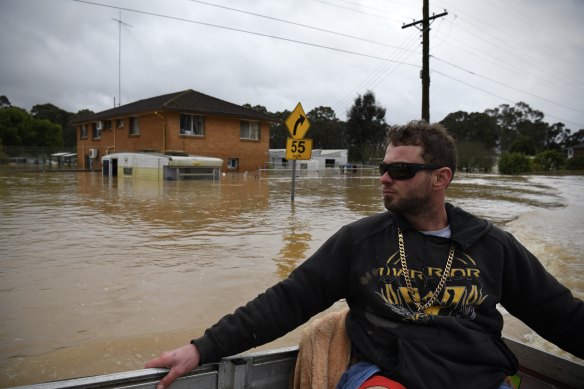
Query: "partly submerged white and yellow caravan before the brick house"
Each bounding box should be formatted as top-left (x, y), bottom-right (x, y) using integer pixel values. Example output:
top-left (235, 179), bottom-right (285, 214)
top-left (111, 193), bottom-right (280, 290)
top-left (101, 152), bottom-right (223, 181)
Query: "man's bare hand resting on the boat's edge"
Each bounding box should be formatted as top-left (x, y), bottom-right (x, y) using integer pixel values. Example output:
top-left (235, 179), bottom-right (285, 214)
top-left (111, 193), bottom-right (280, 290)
top-left (144, 344), bottom-right (201, 389)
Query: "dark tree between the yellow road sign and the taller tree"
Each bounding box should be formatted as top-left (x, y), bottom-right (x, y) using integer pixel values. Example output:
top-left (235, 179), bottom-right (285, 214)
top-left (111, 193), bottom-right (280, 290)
top-left (306, 106), bottom-right (348, 149)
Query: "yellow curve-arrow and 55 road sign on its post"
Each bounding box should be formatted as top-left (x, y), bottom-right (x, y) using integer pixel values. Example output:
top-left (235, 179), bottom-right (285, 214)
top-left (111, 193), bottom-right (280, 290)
top-left (284, 103), bottom-right (312, 201)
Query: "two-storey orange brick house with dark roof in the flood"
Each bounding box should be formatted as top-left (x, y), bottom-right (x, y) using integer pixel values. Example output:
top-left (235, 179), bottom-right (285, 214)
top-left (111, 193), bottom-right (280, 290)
top-left (73, 89), bottom-right (275, 172)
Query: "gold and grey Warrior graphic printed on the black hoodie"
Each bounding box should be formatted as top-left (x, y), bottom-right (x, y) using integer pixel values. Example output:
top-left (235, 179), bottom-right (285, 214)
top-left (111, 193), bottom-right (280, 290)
top-left (378, 252), bottom-right (487, 321)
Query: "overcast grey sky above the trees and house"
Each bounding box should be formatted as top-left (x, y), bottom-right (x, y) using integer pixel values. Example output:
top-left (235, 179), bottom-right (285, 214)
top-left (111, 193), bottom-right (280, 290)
top-left (0, 0), bottom-right (584, 131)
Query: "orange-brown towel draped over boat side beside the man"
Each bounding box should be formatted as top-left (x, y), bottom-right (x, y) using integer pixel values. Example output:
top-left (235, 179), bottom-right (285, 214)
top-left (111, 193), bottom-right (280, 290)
top-left (291, 308), bottom-right (351, 389)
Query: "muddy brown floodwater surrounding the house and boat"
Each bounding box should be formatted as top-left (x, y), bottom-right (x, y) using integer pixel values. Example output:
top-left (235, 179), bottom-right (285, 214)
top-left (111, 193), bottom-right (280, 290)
top-left (0, 170), bottom-right (584, 387)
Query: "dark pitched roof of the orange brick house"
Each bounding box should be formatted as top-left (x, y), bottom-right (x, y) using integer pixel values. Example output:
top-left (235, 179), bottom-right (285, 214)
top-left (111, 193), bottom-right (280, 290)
top-left (73, 89), bottom-right (276, 124)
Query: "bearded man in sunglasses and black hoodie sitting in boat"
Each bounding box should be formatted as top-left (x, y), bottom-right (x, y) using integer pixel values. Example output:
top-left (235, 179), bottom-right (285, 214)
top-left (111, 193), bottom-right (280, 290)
top-left (146, 121), bottom-right (584, 389)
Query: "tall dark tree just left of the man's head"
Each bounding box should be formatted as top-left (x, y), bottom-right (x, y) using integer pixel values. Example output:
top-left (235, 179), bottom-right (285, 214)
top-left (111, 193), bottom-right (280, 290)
top-left (347, 91), bottom-right (387, 163)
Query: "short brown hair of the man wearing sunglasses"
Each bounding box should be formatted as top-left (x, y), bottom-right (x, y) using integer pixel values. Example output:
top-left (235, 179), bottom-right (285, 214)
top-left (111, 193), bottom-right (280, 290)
top-left (387, 120), bottom-right (456, 176)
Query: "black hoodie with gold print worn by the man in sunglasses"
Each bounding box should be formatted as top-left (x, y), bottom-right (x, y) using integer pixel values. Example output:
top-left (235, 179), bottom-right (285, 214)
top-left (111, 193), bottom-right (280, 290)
top-left (192, 204), bottom-right (584, 389)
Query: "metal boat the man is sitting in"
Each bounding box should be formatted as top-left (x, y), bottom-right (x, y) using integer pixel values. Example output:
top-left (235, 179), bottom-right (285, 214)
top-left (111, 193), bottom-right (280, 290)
top-left (10, 338), bottom-right (584, 389)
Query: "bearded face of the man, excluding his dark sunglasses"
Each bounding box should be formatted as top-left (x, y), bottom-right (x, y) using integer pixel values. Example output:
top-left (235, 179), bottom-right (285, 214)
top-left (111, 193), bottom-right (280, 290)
top-left (380, 144), bottom-right (432, 213)
